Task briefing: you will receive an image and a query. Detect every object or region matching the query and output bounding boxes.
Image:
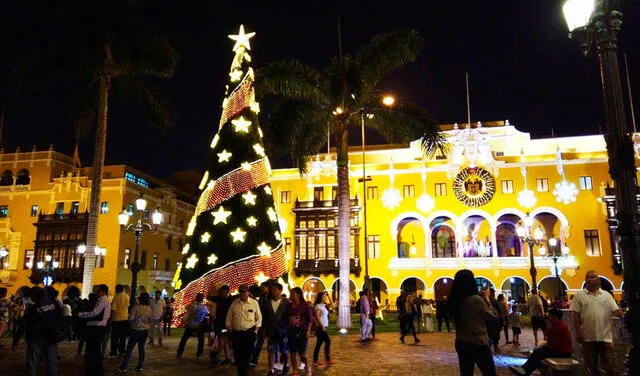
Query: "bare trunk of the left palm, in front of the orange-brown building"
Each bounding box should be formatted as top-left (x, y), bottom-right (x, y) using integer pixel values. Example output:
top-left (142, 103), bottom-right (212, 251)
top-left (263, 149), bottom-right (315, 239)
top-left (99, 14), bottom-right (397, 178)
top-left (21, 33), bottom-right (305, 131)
top-left (82, 74), bottom-right (111, 297)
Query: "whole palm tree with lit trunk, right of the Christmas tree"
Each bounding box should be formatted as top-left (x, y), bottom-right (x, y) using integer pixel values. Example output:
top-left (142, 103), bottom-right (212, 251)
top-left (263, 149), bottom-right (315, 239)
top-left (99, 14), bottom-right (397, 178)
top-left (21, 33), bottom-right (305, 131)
top-left (256, 30), bottom-right (444, 329)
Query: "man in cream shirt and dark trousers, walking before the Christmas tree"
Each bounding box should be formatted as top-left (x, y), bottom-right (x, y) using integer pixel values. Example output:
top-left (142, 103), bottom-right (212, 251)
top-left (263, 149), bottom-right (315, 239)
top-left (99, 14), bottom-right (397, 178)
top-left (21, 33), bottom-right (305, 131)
top-left (225, 284), bottom-right (262, 376)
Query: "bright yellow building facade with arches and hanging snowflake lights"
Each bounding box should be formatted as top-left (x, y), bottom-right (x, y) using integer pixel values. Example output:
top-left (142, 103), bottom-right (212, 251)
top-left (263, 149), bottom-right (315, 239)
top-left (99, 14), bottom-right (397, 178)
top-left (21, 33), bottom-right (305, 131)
top-left (272, 121), bottom-right (622, 304)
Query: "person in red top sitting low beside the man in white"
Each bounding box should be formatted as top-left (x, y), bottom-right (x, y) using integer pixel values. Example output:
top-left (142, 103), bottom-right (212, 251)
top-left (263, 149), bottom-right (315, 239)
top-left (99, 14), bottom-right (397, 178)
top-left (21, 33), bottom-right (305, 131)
top-left (509, 308), bottom-right (573, 376)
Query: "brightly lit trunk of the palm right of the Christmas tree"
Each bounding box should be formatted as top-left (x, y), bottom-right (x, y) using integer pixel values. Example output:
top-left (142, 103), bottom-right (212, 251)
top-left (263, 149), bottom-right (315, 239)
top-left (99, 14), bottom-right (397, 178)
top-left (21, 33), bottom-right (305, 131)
top-left (336, 120), bottom-right (351, 329)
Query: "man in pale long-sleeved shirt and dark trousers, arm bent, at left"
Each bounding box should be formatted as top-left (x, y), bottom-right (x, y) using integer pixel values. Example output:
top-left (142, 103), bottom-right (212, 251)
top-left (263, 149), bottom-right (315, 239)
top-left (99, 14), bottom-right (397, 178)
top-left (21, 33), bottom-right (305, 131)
top-left (78, 285), bottom-right (111, 376)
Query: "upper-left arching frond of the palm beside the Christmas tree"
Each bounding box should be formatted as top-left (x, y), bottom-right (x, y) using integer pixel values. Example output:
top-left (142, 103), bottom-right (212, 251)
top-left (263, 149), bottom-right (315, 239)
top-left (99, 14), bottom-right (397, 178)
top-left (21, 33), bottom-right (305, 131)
top-left (256, 61), bottom-right (328, 105)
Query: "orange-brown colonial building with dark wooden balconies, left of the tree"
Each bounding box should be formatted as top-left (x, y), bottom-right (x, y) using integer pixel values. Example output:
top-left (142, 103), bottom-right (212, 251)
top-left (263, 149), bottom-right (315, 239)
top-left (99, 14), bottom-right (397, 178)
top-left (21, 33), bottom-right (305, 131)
top-left (0, 147), bottom-right (195, 296)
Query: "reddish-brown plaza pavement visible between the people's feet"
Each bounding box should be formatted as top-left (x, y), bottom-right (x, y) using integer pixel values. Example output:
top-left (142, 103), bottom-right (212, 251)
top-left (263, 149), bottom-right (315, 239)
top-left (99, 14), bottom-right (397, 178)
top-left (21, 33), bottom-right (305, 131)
top-left (0, 328), bottom-right (533, 376)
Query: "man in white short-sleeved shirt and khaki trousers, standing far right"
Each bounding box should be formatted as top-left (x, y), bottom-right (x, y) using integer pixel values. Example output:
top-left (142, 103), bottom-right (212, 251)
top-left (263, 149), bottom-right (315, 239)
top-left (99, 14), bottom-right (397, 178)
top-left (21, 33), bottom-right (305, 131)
top-left (570, 270), bottom-right (623, 375)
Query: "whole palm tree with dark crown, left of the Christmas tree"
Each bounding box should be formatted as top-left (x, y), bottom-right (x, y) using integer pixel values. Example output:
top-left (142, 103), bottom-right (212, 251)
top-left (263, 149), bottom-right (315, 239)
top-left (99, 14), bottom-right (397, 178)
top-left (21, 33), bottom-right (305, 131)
top-left (46, 0), bottom-right (178, 296)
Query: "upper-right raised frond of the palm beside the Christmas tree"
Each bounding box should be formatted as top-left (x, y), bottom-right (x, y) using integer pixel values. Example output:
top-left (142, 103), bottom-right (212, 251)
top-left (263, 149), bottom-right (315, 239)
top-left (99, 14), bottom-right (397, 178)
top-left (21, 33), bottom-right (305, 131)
top-left (356, 29), bottom-right (424, 96)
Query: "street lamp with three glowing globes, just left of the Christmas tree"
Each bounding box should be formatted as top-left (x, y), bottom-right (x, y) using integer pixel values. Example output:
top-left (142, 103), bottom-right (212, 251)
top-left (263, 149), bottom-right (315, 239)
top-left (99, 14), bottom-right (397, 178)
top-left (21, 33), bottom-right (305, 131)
top-left (118, 194), bottom-right (162, 312)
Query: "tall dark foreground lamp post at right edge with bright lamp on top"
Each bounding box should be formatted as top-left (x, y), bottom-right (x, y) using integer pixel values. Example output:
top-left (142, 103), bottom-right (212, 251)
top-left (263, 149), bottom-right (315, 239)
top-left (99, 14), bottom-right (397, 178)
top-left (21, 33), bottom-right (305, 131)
top-left (563, 0), bottom-right (640, 375)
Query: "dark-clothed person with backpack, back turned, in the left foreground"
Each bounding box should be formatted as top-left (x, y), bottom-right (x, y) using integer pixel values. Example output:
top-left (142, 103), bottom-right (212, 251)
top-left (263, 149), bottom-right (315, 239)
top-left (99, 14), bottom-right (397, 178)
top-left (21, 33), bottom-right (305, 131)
top-left (24, 286), bottom-right (64, 376)
